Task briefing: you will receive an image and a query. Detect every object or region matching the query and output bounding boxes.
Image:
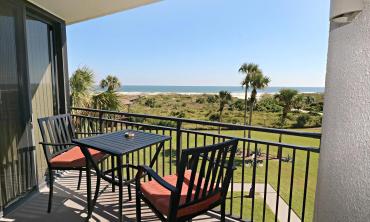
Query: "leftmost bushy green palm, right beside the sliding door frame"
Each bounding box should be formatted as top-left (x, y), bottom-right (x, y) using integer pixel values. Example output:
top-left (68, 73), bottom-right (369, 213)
top-left (69, 67), bottom-right (94, 107)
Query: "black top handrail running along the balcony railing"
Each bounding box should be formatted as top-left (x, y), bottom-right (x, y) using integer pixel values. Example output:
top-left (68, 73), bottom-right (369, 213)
top-left (71, 107), bottom-right (321, 139)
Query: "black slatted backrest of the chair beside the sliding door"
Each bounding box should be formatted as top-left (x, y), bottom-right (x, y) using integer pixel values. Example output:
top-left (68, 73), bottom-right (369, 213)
top-left (37, 114), bottom-right (75, 160)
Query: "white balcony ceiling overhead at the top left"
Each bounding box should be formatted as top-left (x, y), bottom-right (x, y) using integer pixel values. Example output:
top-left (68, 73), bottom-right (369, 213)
top-left (28, 0), bottom-right (159, 24)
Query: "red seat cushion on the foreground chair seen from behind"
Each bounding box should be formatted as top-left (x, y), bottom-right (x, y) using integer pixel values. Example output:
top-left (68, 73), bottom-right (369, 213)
top-left (141, 170), bottom-right (221, 217)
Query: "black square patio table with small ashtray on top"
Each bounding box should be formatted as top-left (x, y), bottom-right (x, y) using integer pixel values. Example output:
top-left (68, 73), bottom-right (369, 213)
top-left (72, 130), bottom-right (171, 221)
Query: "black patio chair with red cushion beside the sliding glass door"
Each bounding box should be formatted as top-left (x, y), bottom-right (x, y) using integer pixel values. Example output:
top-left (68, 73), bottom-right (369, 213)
top-left (37, 114), bottom-right (107, 213)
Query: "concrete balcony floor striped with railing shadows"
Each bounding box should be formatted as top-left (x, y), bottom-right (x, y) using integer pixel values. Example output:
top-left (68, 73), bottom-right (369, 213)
top-left (0, 171), bottom-right (225, 222)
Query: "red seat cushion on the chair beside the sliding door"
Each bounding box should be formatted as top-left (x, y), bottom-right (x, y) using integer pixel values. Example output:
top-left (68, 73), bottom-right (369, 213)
top-left (50, 146), bottom-right (105, 168)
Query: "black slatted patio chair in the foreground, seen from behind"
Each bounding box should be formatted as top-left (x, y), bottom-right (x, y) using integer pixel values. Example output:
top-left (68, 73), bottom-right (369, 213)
top-left (136, 139), bottom-right (238, 222)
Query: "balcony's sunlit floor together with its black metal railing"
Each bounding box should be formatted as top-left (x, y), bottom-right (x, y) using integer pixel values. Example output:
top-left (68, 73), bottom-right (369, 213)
top-left (2, 108), bottom-right (321, 221)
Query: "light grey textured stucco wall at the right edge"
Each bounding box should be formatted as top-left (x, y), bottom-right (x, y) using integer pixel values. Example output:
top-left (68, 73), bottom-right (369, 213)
top-left (315, 3), bottom-right (370, 222)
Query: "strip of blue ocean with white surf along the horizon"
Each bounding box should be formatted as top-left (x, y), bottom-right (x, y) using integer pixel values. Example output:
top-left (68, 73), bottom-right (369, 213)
top-left (118, 85), bottom-right (325, 94)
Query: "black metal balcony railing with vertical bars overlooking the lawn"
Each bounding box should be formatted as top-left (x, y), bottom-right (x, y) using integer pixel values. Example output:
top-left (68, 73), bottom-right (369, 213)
top-left (71, 108), bottom-right (321, 221)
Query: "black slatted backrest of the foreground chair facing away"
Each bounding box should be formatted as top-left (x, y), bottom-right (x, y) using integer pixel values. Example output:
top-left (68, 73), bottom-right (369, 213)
top-left (170, 139), bottom-right (238, 218)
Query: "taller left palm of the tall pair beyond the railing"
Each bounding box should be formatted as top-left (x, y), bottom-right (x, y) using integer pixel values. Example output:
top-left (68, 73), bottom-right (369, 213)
top-left (239, 63), bottom-right (261, 128)
